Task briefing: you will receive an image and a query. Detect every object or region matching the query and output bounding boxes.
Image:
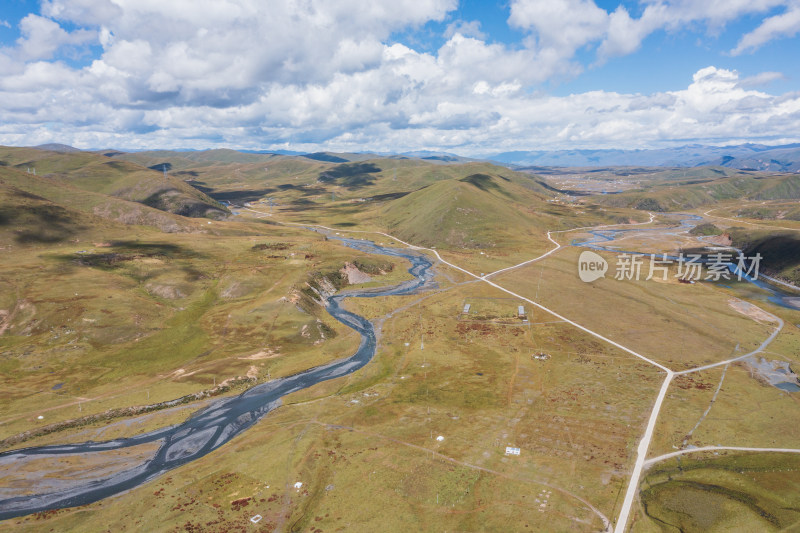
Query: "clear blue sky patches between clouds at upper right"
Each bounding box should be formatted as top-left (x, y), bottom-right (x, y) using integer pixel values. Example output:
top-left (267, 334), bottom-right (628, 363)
top-left (395, 0), bottom-right (800, 95)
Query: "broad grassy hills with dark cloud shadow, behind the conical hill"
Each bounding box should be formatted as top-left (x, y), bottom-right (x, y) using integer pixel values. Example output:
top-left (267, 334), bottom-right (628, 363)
top-left (107, 150), bottom-right (556, 208)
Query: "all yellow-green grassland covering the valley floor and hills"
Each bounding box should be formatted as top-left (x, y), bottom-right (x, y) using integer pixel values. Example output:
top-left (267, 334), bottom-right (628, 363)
top-left (0, 151), bottom-right (800, 532)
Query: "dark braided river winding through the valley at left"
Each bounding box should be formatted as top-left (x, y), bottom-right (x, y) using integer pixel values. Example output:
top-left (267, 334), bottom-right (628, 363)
top-left (0, 235), bottom-right (433, 520)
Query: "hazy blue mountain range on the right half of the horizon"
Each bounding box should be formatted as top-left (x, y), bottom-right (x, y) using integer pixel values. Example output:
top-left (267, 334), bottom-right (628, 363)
top-left (486, 144), bottom-right (800, 172)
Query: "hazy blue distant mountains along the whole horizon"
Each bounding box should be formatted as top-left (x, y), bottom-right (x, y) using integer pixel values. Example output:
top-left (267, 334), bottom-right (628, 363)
top-left (28, 144), bottom-right (800, 172)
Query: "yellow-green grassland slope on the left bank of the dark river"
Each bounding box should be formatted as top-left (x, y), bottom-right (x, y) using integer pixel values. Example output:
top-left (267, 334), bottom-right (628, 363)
top-left (0, 198), bottom-right (418, 450)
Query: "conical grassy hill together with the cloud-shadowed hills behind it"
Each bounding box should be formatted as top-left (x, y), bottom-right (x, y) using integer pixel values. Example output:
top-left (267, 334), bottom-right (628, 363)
top-left (138, 152), bottom-right (646, 256)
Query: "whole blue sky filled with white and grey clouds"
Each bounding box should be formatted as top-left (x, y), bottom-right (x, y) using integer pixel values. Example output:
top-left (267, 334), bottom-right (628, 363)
top-left (0, 0), bottom-right (800, 156)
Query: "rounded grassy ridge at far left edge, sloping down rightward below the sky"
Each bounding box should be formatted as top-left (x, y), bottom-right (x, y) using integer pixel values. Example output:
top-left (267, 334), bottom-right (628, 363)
top-left (0, 147), bottom-right (227, 219)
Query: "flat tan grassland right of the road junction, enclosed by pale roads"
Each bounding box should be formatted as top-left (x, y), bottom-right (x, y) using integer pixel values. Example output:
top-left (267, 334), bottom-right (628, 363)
top-left (496, 243), bottom-right (772, 370)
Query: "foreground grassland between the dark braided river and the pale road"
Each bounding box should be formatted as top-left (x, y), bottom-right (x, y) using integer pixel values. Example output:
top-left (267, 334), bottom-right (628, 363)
top-left (3, 270), bottom-right (659, 531)
